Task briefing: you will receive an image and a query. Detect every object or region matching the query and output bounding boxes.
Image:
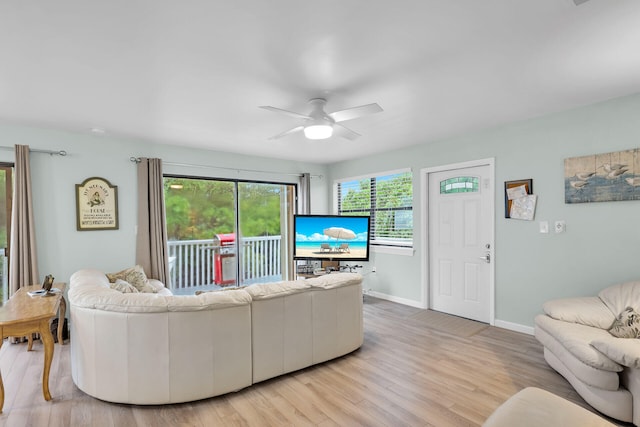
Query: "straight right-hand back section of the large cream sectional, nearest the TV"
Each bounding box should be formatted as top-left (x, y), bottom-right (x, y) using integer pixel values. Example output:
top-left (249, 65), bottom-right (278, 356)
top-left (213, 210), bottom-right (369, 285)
top-left (246, 273), bottom-right (363, 383)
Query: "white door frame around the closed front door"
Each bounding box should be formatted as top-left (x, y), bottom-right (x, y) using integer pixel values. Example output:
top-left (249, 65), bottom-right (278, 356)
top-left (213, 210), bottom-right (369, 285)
top-left (420, 157), bottom-right (496, 326)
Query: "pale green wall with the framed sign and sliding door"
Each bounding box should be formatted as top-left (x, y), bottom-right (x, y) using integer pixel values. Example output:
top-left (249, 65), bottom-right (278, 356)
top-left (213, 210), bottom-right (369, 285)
top-left (0, 124), bottom-right (328, 288)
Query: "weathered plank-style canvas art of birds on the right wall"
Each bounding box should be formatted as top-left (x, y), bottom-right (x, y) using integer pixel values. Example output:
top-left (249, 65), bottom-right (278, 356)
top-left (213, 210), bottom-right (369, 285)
top-left (564, 148), bottom-right (640, 203)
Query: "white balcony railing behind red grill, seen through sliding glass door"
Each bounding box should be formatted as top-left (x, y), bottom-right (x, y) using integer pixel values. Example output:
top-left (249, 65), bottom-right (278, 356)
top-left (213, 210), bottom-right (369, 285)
top-left (167, 236), bottom-right (282, 293)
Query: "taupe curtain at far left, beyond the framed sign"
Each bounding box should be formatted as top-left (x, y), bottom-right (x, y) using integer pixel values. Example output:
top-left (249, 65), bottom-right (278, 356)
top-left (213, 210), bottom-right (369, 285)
top-left (9, 145), bottom-right (40, 295)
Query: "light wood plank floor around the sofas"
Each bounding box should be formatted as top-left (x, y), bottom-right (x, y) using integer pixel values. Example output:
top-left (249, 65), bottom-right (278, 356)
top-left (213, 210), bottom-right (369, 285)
top-left (0, 296), bottom-right (632, 427)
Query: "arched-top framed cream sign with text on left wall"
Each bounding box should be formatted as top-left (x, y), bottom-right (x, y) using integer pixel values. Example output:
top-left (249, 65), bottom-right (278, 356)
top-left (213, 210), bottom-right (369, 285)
top-left (76, 177), bottom-right (118, 231)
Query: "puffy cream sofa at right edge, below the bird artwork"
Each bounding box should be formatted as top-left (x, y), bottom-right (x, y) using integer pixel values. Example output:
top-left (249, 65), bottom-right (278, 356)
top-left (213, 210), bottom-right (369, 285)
top-left (535, 282), bottom-right (640, 426)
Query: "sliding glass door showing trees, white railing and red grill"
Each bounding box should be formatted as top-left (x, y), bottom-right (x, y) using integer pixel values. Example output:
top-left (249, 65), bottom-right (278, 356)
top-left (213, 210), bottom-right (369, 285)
top-left (164, 176), bottom-right (295, 294)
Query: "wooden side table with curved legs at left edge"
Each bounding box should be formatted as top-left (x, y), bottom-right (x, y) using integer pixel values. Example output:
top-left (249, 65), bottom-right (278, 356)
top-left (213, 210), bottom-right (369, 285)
top-left (0, 283), bottom-right (67, 413)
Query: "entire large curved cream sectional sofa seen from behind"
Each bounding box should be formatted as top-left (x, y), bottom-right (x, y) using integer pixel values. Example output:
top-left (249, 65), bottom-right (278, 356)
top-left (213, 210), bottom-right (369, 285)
top-left (69, 269), bottom-right (363, 405)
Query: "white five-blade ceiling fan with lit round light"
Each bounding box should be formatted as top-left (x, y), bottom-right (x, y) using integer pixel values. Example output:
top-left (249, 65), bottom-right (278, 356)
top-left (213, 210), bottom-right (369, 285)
top-left (260, 98), bottom-right (383, 140)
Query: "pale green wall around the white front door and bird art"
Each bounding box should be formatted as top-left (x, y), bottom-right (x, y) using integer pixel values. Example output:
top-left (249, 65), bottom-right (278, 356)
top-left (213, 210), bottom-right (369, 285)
top-left (329, 95), bottom-right (640, 326)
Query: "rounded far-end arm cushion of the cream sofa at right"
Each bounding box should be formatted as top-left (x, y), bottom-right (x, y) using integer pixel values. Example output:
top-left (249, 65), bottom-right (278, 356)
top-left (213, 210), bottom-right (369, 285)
top-left (542, 297), bottom-right (618, 329)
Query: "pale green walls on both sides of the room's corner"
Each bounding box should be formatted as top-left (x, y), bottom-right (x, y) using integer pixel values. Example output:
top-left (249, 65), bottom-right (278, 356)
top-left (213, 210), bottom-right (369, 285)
top-left (0, 95), bottom-right (640, 326)
